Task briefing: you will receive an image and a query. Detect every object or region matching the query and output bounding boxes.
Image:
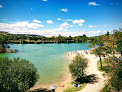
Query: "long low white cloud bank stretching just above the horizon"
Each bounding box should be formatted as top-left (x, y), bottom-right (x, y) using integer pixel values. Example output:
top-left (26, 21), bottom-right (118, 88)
top-left (0, 22), bottom-right (106, 37)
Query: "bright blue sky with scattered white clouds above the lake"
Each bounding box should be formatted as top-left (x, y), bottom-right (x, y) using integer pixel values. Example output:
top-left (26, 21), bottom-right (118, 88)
top-left (0, 0), bottom-right (122, 37)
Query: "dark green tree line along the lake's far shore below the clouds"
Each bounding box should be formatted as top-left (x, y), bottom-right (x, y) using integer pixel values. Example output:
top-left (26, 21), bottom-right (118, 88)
top-left (0, 33), bottom-right (95, 43)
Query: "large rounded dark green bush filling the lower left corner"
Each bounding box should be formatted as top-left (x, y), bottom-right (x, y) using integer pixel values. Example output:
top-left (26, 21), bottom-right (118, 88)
top-left (0, 57), bottom-right (38, 92)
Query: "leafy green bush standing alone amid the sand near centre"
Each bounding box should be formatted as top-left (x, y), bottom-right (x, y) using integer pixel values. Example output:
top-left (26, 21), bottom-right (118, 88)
top-left (69, 55), bottom-right (87, 78)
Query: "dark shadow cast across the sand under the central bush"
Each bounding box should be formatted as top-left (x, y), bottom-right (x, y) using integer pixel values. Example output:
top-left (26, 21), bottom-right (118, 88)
top-left (75, 74), bottom-right (98, 84)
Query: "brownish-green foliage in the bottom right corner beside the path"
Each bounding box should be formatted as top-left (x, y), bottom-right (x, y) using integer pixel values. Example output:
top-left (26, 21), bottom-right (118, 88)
top-left (98, 57), bottom-right (122, 92)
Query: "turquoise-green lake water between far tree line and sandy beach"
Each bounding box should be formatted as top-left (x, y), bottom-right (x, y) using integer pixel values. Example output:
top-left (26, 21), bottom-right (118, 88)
top-left (0, 43), bottom-right (89, 83)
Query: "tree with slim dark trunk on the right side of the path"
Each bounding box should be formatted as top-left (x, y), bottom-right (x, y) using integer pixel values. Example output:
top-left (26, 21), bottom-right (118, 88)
top-left (88, 36), bottom-right (104, 69)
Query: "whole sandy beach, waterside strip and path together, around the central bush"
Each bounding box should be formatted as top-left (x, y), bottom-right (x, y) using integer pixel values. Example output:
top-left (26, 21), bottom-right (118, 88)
top-left (31, 50), bottom-right (107, 92)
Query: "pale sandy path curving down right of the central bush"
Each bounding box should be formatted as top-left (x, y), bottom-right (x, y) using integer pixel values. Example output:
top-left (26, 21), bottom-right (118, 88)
top-left (78, 51), bottom-right (106, 92)
